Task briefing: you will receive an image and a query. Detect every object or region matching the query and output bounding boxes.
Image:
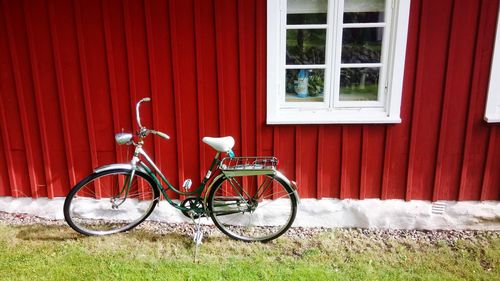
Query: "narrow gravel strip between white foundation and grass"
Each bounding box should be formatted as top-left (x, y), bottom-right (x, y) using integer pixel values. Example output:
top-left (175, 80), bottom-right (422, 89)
top-left (0, 211), bottom-right (500, 246)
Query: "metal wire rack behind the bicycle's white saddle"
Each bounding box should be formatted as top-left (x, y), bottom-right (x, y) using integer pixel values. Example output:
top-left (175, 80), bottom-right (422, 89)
top-left (219, 157), bottom-right (279, 171)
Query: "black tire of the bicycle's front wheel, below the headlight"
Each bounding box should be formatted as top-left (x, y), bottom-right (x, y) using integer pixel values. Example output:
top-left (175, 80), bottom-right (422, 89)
top-left (63, 169), bottom-right (160, 236)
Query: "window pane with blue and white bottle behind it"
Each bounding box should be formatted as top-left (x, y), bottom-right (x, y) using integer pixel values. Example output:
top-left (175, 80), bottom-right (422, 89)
top-left (285, 69), bottom-right (325, 102)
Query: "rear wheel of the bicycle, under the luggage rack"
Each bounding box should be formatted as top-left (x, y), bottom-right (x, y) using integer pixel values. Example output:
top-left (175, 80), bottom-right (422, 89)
top-left (208, 175), bottom-right (297, 242)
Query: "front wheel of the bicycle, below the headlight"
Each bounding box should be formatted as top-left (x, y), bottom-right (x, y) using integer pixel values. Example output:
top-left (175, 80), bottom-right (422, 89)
top-left (64, 169), bottom-right (159, 235)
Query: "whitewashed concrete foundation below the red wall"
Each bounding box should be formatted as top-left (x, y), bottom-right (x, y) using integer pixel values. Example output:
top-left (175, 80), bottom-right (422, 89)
top-left (0, 197), bottom-right (500, 230)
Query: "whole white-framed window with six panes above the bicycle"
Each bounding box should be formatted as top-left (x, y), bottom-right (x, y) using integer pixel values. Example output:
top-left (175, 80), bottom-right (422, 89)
top-left (267, 0), bottom-right (410, 124)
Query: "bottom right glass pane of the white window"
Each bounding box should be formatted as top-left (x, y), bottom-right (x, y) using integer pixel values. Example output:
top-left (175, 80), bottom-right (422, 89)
top-left (340, 67), bottom-right (380, 101)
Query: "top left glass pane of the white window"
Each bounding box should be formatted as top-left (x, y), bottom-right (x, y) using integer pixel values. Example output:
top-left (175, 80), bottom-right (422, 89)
top-left (286, 0), bottom-right (328, 24)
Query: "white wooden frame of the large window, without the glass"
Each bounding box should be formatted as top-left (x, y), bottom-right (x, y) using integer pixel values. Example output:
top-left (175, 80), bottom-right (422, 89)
top-left (267, 0), bottom-right (410, 124)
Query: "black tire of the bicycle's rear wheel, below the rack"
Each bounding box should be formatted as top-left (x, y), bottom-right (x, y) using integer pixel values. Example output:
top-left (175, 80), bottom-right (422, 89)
top-left (207, 173), bottom-right (298, 243)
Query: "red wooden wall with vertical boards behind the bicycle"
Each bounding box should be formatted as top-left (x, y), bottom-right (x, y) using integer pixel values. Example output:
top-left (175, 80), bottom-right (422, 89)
top-left (0, 0), bottom-right (500, 200)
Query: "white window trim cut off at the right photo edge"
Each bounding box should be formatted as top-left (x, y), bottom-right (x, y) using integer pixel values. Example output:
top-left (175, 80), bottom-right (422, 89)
top-left (484, 10), bottom-right (500, 123)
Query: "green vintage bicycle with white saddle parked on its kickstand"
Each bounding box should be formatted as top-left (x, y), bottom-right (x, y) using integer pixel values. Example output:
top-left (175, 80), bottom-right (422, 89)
top-left (64, 98), bottom-right (299, 243)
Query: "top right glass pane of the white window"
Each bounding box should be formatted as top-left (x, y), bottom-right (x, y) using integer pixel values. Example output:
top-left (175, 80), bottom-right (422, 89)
top-left (344, 0), bottom-right (385, 23)
